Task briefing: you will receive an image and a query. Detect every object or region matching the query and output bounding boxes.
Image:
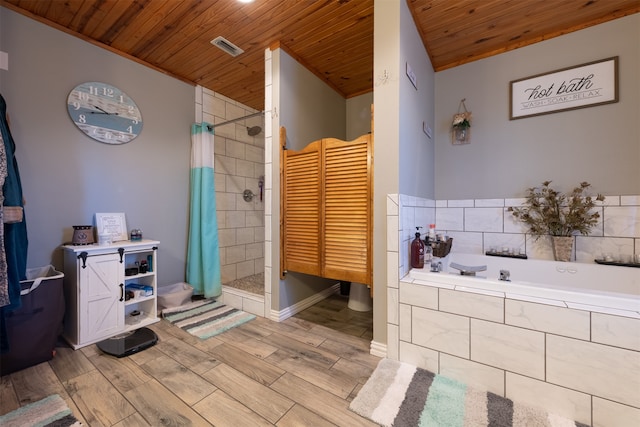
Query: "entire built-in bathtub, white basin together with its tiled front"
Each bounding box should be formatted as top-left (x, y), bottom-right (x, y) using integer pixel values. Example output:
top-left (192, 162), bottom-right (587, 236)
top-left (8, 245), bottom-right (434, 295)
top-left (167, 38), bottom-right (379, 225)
top-left (398, 253), bottom-right (640, 425)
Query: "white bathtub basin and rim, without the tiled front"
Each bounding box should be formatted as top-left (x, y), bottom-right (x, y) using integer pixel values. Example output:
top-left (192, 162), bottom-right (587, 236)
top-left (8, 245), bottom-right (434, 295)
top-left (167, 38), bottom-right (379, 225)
top-left (407, 253), bottom-right (640, 317)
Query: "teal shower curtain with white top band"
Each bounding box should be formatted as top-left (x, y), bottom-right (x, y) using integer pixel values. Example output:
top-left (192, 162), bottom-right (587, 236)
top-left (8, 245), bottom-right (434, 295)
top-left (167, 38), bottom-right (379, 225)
top-left (187, 123), bottom-right (222, 298)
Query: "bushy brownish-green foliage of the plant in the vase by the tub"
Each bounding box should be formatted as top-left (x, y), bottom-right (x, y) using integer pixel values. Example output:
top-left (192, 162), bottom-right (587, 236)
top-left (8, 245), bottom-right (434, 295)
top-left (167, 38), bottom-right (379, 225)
top-left (507, 181), bottom-right (604, 240)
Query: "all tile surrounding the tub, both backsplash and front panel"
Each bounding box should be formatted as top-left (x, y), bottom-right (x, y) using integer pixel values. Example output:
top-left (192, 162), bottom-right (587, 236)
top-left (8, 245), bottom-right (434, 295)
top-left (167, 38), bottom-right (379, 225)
top-left (387, 195), bottom-right (640, 426)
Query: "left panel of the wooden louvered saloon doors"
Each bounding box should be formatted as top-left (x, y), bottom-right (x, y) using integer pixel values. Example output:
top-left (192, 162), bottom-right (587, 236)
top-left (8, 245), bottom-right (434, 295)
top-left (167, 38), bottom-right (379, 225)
top-left (282, 141), bottom-right (321, 276)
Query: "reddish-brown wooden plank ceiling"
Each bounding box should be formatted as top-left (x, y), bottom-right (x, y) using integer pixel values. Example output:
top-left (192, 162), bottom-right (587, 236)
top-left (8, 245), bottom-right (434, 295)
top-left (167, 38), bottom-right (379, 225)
top-left (0, 0), bottom-right (640, 110)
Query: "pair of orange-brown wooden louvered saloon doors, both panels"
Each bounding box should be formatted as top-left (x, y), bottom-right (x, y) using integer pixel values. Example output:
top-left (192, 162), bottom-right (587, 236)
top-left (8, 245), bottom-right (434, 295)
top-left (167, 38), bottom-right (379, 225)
top-left (282, 130), bottom-right (373, 285)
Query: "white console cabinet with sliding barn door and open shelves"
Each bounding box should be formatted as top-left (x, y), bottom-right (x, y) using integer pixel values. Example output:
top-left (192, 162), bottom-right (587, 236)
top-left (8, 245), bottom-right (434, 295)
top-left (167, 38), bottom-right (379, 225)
top-left (63, 240), bottom-right (160, 349)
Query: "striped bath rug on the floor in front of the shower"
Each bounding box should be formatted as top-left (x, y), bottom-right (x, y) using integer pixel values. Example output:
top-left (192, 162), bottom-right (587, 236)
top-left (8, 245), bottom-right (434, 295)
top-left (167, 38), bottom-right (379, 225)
top-left (162, 299), bottom-right (256, 340)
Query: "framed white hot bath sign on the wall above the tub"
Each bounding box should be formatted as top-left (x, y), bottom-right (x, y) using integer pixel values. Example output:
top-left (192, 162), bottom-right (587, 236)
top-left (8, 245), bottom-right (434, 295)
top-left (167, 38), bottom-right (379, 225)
top-left (509, 56), bottom-right (618, 120)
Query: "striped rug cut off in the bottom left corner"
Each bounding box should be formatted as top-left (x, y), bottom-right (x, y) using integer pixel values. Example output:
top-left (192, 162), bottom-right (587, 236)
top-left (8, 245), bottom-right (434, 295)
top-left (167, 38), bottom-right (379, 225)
top-left (0, 394), bottom-right (82, 427)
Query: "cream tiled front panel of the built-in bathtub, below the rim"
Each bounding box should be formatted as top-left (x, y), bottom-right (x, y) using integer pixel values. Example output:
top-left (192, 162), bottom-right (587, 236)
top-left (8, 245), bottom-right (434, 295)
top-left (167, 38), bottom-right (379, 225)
top-left (396, 272), bottom-right (640, 426)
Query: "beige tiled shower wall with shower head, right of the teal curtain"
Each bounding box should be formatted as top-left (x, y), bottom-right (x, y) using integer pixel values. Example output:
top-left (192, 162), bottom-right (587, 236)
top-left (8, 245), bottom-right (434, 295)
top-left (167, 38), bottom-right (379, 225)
top-left (196, 87), bottom-right (265, 284)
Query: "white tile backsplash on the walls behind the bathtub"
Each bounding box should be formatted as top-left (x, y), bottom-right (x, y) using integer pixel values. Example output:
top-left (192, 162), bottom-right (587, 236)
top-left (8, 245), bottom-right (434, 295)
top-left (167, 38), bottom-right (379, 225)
top-left (396, 195), bottom-right (640, 277)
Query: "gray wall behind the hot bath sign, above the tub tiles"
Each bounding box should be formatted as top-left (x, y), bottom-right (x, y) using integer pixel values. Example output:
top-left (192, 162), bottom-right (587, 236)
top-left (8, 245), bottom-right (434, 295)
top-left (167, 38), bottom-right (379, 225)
top-left (435, 14), bottom-right (640, 199)
